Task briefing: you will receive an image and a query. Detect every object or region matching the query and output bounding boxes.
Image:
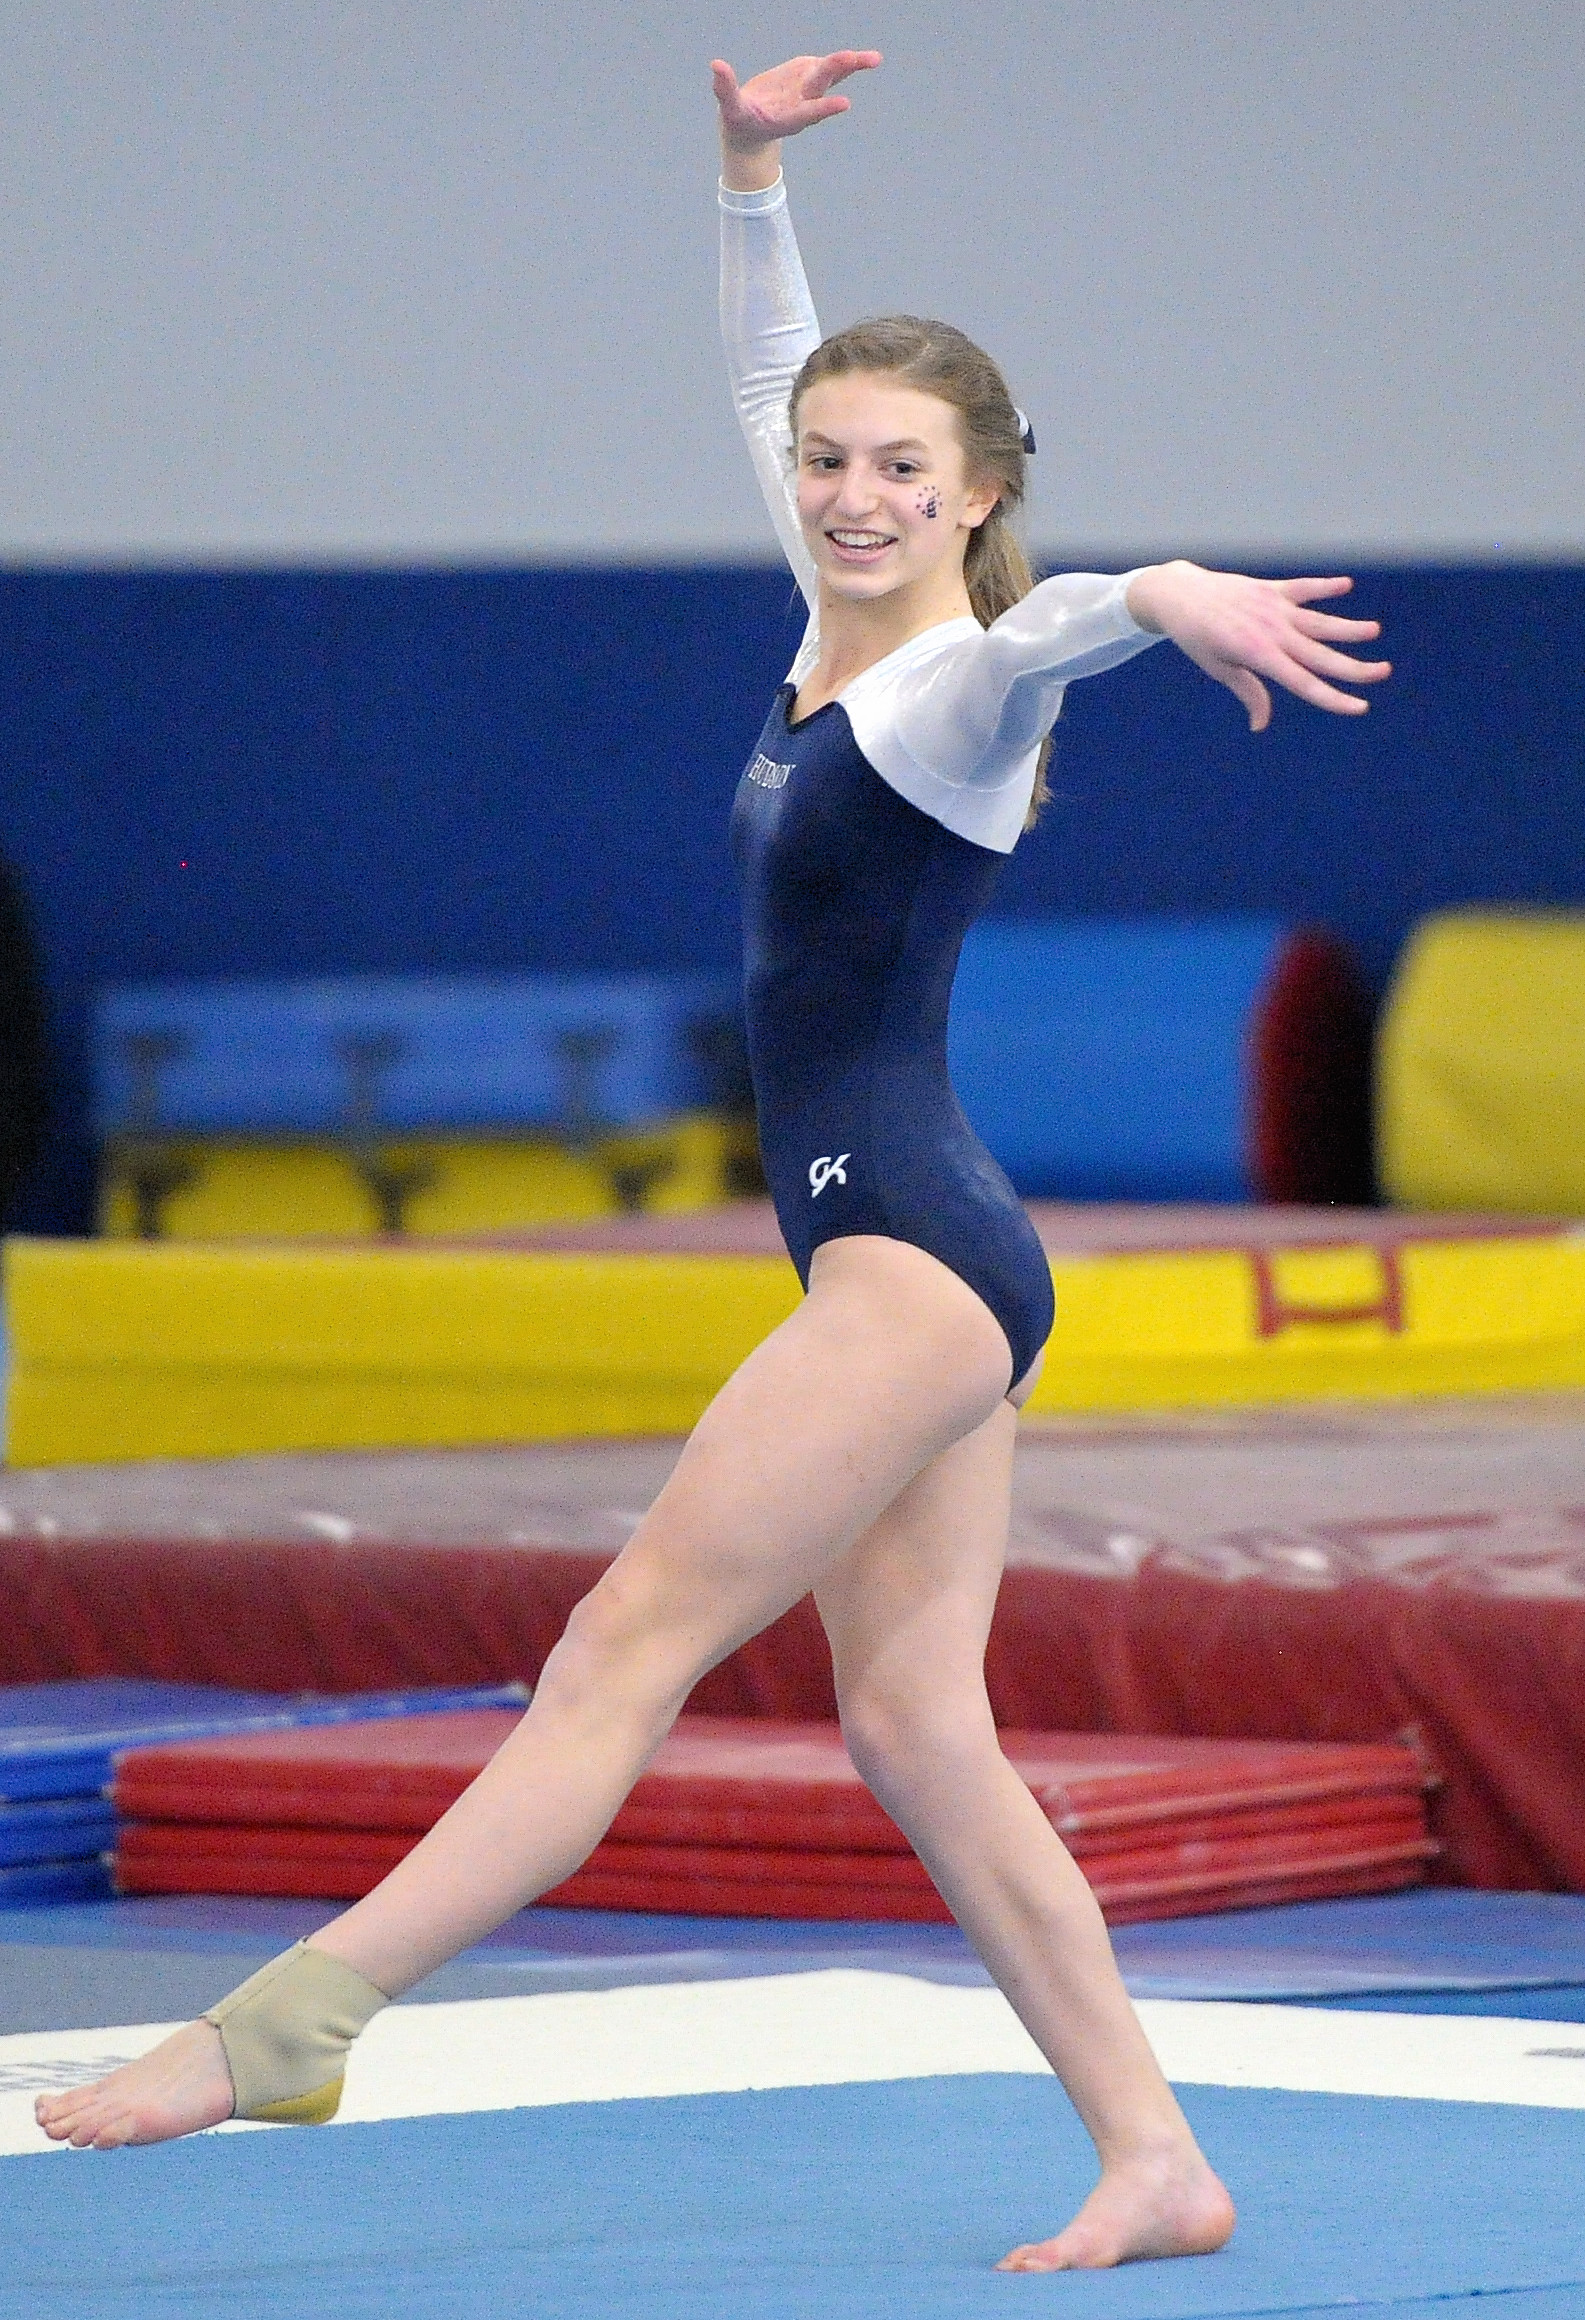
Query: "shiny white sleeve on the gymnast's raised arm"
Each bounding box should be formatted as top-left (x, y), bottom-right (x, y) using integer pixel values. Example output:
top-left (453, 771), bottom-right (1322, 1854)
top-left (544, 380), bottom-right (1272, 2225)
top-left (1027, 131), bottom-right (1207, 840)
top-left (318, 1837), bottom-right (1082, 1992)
top-left (722, 179), bottom-right (819, 610)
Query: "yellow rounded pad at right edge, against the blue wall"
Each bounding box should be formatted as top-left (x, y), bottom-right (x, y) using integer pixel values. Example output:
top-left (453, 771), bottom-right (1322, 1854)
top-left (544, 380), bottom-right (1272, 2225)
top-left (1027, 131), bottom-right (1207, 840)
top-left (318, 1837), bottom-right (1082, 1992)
top-left (1376, 909), bottom-right (1585, 1216)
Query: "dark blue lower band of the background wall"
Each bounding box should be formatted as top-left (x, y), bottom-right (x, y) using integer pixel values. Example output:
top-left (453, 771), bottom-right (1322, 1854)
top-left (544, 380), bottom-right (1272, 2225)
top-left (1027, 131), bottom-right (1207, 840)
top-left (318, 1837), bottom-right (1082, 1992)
top-left (0, 566), bottom-right (1585, 1230)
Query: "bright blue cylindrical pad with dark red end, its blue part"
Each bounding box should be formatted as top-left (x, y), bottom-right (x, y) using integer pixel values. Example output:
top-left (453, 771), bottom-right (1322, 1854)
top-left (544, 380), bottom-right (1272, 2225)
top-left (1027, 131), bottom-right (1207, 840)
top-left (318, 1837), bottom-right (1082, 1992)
top-left (949, 919), bottom-right (1288, 1199)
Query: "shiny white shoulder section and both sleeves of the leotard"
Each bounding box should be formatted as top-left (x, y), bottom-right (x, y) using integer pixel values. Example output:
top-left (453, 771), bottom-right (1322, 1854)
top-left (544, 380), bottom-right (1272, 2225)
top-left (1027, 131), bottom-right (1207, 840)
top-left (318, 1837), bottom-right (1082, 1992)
top-left (722, 179), bottom-right (1158, 854)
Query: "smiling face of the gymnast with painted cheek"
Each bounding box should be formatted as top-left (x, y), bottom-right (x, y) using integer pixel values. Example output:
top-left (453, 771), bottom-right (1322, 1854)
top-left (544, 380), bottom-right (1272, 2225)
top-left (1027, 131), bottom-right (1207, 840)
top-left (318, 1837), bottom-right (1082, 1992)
top-left (798, 371), bottom-right (998, 599)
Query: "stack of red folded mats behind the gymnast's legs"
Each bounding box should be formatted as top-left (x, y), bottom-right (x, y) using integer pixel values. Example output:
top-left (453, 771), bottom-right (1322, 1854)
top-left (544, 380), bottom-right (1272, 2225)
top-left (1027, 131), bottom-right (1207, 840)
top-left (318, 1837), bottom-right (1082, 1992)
top-left (114, 1710), bottom-right (1436, 1923)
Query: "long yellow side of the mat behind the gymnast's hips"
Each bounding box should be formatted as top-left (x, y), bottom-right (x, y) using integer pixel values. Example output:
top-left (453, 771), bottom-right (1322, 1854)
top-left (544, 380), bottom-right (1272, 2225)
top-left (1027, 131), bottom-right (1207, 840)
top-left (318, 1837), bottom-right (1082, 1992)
top-left (5, 1232), bottom-right (1585, 1466)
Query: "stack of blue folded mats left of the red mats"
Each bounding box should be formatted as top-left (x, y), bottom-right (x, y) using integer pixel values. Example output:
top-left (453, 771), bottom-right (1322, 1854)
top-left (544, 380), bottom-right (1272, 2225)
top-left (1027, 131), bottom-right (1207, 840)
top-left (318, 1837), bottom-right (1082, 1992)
top-left (0, 1675), bottom-right (529, 1907)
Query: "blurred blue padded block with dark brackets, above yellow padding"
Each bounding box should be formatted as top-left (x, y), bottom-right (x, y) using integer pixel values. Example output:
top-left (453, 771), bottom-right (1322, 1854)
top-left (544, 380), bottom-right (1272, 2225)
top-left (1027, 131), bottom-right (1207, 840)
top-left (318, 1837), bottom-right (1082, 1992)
top-left (93, 974), bottom-right (738, 1134)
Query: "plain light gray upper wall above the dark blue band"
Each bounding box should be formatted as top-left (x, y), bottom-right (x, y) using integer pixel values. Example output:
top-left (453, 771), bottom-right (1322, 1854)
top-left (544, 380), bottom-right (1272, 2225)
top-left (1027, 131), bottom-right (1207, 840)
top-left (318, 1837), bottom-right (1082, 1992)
top-left (0, 0), bottom-right (1585, 561)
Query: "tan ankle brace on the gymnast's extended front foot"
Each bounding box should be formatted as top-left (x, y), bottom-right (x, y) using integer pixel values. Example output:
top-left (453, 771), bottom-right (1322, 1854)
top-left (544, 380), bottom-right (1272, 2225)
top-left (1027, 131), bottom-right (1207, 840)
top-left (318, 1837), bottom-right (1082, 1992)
top-left (204, 1942), bottom-right (390, 2127)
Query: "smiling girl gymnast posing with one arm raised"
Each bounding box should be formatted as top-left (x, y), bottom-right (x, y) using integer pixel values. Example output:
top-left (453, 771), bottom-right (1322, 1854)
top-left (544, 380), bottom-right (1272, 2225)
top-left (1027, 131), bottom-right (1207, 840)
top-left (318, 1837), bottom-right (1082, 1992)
top-left (37, 49), bottom-right (1388, 2271)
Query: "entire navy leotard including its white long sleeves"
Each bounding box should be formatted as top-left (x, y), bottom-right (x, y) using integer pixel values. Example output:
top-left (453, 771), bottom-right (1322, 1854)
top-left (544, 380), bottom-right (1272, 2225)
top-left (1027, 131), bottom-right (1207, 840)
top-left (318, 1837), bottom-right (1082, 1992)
top-left (722, 179), bottom-right (1153, 1383)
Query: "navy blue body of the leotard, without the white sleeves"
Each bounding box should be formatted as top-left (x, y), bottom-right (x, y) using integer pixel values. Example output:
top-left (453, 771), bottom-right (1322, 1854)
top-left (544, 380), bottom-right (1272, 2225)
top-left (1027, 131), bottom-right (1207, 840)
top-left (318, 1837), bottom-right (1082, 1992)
top-left (733, 684), bottom-right (1051, 1380)
